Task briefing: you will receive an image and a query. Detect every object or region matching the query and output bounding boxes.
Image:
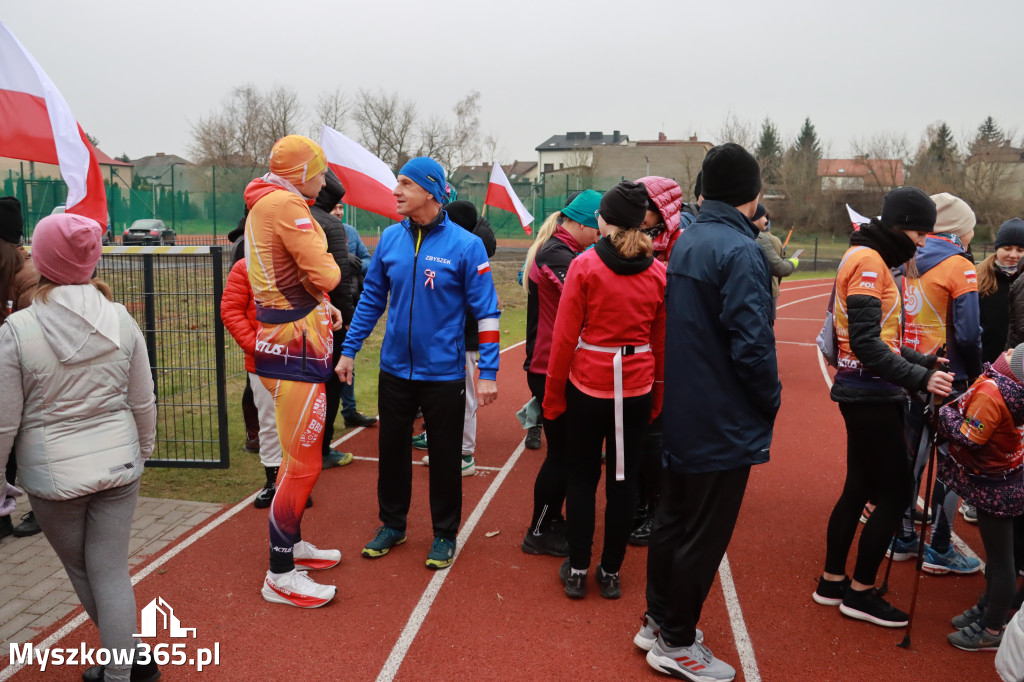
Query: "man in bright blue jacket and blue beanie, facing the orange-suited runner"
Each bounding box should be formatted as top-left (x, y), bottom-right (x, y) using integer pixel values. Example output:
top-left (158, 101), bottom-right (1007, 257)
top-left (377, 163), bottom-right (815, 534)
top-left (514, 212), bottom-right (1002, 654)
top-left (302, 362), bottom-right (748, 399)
top-left (337, 157), bottom-right (501, 568)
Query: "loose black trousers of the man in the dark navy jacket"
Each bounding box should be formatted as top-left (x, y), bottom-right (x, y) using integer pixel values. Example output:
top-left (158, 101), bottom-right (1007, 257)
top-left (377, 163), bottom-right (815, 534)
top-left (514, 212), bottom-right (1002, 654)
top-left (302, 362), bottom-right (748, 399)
top-left (647, 466), bottom-right (751, 646)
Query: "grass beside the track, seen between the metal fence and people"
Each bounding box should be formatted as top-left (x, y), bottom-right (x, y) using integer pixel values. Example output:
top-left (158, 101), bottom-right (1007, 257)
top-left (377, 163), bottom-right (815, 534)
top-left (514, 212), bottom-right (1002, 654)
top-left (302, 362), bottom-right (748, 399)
top-left (141, 261), bottom-right (526, 504)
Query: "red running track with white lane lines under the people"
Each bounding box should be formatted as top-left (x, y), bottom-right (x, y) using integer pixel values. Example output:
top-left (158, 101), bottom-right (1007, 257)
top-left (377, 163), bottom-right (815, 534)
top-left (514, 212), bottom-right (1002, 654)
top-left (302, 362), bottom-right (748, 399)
top-left (0, 282), bottom-right (998, 682)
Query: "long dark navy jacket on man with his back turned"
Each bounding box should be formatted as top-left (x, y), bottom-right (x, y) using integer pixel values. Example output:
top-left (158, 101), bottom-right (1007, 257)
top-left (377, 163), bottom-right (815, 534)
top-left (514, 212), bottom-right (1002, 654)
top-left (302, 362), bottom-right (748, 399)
top-left (662, 200), bottom-right (781, 473)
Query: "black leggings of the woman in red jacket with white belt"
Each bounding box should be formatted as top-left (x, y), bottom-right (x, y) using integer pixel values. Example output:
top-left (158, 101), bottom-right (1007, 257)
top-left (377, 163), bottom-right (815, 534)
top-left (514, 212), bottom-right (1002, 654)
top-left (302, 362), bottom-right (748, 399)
top-left (564, 381), bottom-right (651, 573)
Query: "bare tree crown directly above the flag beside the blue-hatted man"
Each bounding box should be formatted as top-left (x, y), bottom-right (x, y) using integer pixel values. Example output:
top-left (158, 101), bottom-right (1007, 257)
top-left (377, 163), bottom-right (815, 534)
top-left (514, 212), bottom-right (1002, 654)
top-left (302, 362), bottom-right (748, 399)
top-left (352, 90), bottom-right (416, 169)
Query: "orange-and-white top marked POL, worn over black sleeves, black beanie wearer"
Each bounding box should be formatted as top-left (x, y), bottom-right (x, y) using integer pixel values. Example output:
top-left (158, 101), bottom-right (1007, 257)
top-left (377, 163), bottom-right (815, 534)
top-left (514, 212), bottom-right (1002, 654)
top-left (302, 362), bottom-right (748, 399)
top-left (835, 247), bottom-right (901, 383)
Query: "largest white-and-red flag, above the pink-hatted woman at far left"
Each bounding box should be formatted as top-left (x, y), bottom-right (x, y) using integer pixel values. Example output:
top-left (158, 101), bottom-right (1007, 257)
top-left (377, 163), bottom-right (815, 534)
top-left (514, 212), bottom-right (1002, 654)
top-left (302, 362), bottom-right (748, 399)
top-left (0, 22), bottom-right (106, 225)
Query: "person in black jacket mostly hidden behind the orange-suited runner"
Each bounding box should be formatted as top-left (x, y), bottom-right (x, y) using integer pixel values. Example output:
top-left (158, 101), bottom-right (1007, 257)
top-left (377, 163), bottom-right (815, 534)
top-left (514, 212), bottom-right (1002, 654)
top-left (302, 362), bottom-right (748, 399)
top-left (309, 170), bottom-right (355, 469)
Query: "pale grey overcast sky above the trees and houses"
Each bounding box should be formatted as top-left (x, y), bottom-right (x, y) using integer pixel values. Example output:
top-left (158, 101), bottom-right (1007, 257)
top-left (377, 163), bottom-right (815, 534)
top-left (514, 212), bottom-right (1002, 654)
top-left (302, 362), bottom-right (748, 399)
top-left (8, 0), bottom-right (1024, 162)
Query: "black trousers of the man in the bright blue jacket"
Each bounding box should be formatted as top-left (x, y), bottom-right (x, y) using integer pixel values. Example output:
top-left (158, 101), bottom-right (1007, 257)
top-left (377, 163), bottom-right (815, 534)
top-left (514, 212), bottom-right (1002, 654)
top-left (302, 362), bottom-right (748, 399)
top-left (377, 370), bottom-right (466, 542)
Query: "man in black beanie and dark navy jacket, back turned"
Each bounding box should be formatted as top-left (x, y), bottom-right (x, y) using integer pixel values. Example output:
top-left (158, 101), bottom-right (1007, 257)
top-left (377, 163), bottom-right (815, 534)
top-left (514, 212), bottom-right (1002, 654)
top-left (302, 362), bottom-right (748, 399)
top-left (634, 143), bottom-right (781, 680)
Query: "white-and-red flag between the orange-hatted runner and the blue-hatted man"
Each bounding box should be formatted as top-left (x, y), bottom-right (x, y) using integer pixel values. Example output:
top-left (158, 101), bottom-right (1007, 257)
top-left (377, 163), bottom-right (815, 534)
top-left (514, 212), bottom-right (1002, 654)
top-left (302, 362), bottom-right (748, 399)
top-left (321, 126), bottom-right (404, 221)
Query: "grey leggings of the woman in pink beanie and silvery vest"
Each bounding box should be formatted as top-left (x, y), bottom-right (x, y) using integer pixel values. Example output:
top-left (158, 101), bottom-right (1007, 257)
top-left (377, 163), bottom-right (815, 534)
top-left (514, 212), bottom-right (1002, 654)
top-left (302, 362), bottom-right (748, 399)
top-left (29, 480), bottom-right (139, 681)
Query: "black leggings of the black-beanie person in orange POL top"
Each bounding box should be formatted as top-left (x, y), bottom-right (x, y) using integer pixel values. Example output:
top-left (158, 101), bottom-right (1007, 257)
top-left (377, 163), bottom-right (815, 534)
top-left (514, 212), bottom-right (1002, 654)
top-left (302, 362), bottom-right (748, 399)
top-left (825, 402), bottom-right (913, 585)
